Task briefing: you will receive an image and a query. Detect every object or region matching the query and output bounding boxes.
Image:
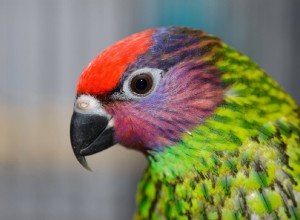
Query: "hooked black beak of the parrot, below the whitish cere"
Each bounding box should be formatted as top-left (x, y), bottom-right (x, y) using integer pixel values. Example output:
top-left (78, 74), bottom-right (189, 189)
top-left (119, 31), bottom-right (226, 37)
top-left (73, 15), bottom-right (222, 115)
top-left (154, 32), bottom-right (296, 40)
top-left (70, 111), bottom-right (114, 170)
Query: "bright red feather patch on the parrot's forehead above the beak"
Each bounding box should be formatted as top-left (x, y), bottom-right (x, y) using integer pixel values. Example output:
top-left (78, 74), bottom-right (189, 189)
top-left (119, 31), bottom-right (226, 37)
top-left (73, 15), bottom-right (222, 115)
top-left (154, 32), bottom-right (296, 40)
top-left (77, 29), bottom-right (155, 95)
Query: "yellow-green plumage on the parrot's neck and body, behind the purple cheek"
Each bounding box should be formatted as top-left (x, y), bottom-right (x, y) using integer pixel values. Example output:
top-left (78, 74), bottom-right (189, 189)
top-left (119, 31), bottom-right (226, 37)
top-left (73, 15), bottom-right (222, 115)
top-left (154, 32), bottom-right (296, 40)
top-left (135, 44), bottom-right (300, 219)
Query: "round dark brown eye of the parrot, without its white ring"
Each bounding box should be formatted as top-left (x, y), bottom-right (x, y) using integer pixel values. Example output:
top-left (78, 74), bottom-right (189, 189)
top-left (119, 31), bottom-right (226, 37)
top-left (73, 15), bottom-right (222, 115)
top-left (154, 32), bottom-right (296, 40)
top-left (130, 73), bottom-right (153, 95)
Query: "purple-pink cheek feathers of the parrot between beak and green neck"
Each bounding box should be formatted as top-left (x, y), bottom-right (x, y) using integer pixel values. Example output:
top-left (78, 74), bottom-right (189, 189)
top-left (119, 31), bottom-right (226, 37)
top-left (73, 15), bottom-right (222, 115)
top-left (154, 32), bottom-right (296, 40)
top-left (109, 62), bottom-right (223, 151)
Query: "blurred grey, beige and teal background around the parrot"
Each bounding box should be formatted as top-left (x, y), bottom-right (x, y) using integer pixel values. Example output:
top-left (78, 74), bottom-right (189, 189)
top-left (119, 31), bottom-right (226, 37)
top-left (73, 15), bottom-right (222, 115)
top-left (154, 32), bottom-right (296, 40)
top-left (0, 0), bottom-right (300, 220)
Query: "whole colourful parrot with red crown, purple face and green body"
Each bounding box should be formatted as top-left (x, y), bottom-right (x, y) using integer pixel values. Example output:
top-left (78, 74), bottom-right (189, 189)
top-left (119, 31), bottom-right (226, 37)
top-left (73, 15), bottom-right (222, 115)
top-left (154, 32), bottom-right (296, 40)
top-left (70, 26), bottom-right (300, 220)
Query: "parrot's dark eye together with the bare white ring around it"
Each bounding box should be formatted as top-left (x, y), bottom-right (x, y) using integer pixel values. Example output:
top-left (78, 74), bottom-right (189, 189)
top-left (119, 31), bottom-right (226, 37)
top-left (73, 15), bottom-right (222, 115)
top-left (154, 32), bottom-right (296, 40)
top-left (123, 67), bottom-right (163, 99)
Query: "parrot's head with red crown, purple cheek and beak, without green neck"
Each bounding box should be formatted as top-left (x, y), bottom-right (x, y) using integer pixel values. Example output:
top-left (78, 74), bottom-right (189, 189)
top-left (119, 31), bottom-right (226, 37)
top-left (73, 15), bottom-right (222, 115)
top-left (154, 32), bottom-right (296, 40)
top-left (71, 28), bottom-right (224, 168)
